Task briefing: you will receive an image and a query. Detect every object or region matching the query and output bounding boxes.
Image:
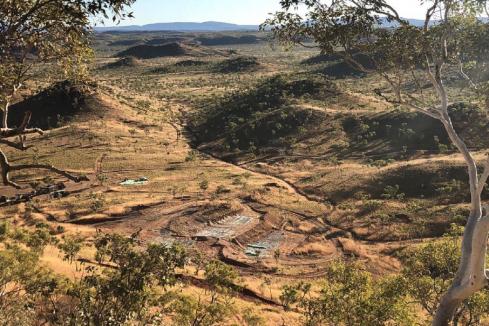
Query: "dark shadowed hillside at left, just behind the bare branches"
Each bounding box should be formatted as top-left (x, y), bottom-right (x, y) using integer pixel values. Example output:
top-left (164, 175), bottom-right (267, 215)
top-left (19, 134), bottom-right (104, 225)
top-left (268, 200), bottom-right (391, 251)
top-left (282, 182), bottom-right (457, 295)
top-left (9, 81), bottom-right (95, 129)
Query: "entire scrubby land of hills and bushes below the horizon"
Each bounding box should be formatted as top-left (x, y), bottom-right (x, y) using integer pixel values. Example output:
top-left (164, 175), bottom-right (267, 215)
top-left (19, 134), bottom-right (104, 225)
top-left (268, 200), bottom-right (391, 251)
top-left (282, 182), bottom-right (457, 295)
top-left (0, 0), bottom-right (489, 326)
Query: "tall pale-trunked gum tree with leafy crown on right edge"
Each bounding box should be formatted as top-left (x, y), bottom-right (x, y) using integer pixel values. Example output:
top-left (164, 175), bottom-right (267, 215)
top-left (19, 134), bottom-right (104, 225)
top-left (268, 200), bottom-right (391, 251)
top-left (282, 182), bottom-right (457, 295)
top-left (264, 0), bottom-right (489, 325)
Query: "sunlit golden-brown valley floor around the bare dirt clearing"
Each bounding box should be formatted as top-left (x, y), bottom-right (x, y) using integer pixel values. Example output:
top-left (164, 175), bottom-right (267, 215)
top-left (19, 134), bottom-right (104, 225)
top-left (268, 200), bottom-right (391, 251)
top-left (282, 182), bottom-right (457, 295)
top-left (0, 42), bottom-right (482, 325)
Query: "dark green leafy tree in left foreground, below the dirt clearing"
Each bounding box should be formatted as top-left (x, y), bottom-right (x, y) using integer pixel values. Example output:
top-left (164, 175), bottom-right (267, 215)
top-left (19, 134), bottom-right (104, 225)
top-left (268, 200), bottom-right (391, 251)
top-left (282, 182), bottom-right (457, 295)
top-left (69, 233), bottom-right (187, 325)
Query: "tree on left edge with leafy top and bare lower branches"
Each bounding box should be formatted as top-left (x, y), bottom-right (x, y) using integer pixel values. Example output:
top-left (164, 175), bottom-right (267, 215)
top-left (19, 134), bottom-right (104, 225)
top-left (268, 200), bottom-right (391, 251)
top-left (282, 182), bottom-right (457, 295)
top-left (0, 0), bottom-right (135, 188)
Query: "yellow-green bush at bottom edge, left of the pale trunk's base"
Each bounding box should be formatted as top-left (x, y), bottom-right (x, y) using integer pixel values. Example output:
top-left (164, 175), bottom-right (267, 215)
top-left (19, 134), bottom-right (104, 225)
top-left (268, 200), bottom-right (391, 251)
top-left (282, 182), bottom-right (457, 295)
top-left (299, 261), bottom-right (413, 326)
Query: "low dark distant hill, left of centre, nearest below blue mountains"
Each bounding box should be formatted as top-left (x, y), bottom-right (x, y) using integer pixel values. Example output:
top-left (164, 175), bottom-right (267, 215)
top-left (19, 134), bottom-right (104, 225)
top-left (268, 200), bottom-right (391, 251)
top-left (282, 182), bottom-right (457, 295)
top-left (116, 42), bottom-right (225, 59)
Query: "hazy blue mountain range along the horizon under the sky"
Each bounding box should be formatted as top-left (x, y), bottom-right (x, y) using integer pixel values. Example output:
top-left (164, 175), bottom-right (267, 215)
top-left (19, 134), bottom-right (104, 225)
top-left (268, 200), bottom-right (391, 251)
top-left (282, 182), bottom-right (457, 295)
top-left (95, 21), bottom-right (259, 32)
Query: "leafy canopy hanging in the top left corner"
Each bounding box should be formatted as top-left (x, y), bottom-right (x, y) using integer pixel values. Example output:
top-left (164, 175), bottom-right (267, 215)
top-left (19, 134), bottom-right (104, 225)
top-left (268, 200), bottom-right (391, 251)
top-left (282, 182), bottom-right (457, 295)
top-left (0, 0), bottom-right (134, 109)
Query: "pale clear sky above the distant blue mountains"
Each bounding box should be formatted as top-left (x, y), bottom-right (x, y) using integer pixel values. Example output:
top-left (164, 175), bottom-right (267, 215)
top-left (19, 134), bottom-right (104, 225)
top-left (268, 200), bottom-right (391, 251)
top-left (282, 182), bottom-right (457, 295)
top-left (101, 0), bottom-right (423, 26)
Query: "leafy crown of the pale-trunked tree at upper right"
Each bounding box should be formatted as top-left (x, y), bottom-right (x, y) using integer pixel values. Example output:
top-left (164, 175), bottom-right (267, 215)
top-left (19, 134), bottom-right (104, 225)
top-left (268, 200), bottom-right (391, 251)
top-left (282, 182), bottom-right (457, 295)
top-left (263, 0), bottom-right (489, 107)
